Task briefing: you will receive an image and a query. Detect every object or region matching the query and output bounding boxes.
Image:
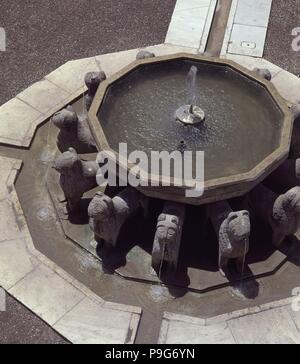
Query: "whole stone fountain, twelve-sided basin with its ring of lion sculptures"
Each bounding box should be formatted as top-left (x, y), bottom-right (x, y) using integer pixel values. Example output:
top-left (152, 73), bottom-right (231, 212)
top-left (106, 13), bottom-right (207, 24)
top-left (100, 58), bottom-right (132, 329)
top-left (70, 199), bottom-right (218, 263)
top-left (52, 51), bottom-right (300, 288)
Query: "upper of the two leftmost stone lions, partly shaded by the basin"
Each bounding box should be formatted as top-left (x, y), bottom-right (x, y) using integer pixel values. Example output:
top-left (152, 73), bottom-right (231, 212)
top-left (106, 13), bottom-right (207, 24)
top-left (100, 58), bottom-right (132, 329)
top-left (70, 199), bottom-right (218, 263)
top-left (51, 106), bottom-right (97, 154)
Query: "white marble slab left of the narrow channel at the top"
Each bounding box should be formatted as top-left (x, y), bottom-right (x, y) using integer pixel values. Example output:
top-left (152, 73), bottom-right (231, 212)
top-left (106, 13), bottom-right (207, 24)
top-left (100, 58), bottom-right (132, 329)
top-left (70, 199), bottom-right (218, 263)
top-left (165, 0), bottom-right (217, 51)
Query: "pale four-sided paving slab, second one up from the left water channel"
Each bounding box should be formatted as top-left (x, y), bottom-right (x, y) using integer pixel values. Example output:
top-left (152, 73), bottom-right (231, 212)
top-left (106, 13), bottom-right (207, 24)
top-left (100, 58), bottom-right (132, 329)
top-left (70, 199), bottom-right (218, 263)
top-left (17, 79), bottom-right (69, 114)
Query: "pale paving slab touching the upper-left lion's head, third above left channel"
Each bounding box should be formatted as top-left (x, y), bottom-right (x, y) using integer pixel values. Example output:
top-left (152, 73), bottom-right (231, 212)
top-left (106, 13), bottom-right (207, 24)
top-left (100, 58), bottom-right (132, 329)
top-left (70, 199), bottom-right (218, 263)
top-left (45, 57), bottom-right (99, 93)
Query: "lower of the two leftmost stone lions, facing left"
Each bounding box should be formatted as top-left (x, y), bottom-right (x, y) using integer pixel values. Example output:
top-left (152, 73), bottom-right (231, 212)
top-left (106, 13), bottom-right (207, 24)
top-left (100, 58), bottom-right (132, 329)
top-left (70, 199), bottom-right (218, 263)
top-left (53, 148), bottom-right (99, 213)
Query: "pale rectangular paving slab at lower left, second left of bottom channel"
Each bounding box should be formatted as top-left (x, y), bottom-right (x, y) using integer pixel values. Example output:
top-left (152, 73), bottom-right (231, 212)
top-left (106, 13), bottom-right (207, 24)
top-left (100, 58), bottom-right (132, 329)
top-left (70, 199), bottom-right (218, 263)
top-left (9, 265), bottom-right (85, 325)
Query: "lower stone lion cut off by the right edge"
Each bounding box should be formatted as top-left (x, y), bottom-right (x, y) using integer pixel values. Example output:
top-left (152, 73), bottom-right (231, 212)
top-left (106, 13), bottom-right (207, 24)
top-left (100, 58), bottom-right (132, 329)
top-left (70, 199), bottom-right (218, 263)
top-left (249, 185), bottom-right (300, 247)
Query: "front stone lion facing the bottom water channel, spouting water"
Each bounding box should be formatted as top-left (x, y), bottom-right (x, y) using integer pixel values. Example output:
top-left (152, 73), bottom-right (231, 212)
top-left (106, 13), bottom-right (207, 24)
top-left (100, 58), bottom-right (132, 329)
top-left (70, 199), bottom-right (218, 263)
top-left (152, 201), bottom-right (185, 272)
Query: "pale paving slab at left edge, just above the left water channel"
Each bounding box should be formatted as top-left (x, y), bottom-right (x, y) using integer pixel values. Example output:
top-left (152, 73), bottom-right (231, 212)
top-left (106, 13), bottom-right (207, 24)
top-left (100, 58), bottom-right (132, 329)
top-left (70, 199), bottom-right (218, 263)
top-left (0, 98), bottom-right (41, 146)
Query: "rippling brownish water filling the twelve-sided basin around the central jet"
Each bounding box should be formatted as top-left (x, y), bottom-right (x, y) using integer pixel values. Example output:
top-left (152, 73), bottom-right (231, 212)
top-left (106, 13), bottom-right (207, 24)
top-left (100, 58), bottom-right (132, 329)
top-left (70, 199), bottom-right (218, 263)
top-left (98, 60), bottom-right (282, 180)
